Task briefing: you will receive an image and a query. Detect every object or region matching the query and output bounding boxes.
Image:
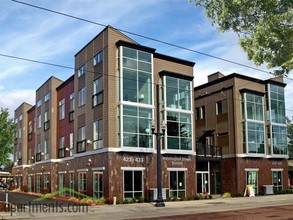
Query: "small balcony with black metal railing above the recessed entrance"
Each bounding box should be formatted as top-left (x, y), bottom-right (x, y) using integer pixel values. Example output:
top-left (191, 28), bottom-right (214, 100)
top-left (196, 146), bottom-right (223, 160)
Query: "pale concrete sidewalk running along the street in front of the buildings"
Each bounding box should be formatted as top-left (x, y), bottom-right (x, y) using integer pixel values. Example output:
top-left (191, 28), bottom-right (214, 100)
top-left (0, 194), bottom-right (293, 219)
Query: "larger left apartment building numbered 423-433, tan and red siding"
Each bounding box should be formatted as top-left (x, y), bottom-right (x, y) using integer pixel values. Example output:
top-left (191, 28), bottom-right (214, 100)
top-left (13, 27), bottom-right (196, 201)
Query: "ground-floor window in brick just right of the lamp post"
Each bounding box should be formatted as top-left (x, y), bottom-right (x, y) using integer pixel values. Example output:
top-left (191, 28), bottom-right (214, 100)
top-left (169, 171), bottom-right (185, 198)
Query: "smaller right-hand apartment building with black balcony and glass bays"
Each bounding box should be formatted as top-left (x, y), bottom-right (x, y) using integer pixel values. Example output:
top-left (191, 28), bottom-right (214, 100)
top-left (194, 72), bottom-right (288, 195)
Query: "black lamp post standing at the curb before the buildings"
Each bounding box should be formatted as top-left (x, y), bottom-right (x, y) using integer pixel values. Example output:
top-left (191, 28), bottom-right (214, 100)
top-left (152, 85), bottom-right (165, 207)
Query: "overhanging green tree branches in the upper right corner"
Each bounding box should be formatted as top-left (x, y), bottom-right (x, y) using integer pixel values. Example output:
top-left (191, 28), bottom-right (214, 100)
top-left (189, 0), bottom-right (293, 75)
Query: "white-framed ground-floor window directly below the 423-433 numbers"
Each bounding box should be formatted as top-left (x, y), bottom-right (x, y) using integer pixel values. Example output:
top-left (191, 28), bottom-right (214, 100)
top-left (123, 170), bottom-right (143, 199)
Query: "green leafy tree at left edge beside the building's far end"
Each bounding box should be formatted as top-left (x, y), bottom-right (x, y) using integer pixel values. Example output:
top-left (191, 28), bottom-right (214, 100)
top-left (0, 108), bottom-right (16, 165)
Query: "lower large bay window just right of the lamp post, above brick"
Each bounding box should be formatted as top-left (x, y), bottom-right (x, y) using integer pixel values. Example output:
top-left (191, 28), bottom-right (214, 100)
top-left (167, 111), bottom-right (192, 150)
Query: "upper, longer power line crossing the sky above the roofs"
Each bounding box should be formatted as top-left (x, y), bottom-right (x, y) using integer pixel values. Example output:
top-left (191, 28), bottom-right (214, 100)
top-left (11, 0), bottom-right (293, 80)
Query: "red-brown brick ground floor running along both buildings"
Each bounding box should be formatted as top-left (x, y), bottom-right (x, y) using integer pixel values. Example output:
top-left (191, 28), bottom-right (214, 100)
top-left (13, 152), bottom-right (288, 201)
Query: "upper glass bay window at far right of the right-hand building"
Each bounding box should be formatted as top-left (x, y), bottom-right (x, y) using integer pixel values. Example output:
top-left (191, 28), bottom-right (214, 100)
top-left (267, 84), bottom-right (286, 124)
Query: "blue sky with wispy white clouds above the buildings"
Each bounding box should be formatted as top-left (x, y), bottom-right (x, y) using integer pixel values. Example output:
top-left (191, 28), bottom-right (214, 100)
top-left (0, 0), bottom-right (293, 118)
